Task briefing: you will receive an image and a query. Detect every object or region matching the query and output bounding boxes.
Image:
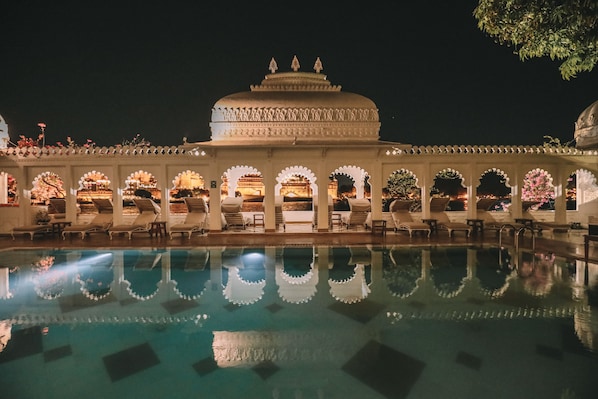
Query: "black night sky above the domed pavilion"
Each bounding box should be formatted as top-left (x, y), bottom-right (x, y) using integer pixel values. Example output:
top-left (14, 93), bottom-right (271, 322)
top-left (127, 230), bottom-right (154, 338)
top-left (0, 0), bottom-right (598, 145)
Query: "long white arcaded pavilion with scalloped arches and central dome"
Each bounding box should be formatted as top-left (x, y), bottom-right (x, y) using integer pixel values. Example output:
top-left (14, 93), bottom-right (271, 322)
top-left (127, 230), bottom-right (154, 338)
top-left (0, 57), bottom-right (598, 233)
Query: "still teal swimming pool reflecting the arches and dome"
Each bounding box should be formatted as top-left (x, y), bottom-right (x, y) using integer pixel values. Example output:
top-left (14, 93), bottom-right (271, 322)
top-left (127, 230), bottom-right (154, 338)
top-left (0, 246), bottom-right (598, 399)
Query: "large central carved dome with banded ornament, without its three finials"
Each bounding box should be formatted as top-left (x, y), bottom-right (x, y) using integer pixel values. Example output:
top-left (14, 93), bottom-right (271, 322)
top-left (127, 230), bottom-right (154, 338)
top-left (210, 58), bottom-right (380, 144)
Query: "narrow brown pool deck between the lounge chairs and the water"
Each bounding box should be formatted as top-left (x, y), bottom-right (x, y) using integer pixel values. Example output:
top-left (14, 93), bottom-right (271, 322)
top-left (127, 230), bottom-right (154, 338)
top-left (0, 225), bottom-right (598, 263)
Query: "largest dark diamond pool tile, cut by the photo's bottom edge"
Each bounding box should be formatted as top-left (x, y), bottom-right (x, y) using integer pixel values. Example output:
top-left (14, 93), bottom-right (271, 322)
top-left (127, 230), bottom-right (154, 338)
top-left (342, 341), bottom-right (425, 399)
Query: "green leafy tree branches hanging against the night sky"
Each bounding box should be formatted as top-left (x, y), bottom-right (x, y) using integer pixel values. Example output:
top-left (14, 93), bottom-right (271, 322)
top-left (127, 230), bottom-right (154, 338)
top-left (473, 0), bottom-right (598, 80)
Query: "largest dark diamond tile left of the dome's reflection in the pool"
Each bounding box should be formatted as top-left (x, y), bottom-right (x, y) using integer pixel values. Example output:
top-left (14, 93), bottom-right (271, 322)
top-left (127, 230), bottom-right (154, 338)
top-left (103, 343), bottom-right (160, 381)
